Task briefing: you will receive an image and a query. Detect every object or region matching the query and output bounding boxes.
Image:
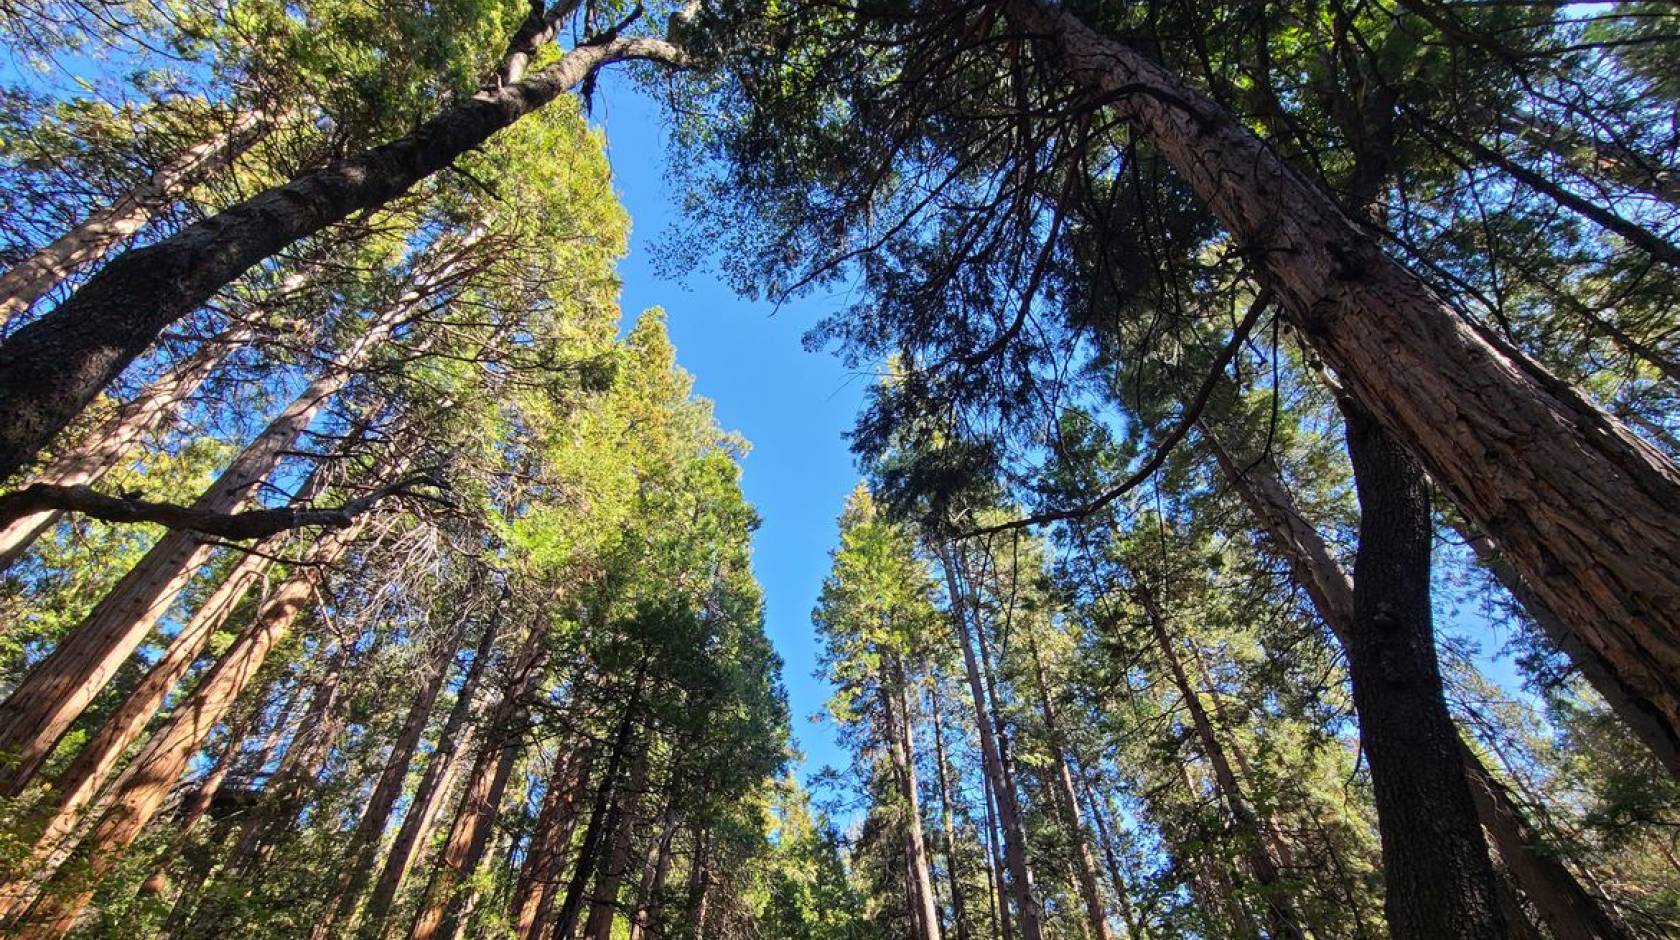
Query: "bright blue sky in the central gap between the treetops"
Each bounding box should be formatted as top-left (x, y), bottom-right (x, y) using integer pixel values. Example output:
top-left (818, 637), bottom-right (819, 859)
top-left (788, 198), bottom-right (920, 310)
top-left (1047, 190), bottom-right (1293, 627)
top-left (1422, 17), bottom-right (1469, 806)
top-left (591, 74), bottom-right (874, 779)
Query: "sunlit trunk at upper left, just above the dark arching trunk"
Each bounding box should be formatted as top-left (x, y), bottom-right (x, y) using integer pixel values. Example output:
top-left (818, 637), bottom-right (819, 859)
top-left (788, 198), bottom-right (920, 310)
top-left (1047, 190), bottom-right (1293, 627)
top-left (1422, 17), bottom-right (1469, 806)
top-left (0, 111), bottom-right (267, 326)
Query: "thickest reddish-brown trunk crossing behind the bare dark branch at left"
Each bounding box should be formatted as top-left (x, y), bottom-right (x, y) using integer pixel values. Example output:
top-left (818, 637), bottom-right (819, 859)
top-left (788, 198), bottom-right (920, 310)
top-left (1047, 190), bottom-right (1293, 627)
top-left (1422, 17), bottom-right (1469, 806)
top-left (0, 304), bottom-right (407, 796)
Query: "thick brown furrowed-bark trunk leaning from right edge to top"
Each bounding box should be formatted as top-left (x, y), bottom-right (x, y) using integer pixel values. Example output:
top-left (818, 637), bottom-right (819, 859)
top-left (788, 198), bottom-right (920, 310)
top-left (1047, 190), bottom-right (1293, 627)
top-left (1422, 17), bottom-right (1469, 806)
top-left (1003, 0), bottom-right (1680, 768)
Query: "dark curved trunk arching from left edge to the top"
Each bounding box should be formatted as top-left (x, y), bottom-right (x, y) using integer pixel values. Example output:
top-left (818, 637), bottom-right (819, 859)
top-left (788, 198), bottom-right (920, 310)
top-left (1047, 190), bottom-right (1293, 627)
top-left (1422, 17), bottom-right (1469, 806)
top-left (0, 37), bottom-right (684, 480)
